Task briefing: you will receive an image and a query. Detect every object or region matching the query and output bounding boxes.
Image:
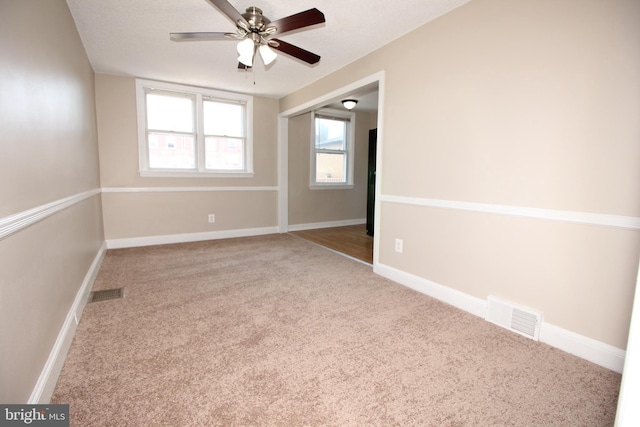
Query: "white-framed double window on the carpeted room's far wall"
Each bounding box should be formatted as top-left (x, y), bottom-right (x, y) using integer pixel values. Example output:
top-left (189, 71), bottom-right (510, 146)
top-left (136, 80), bottom-right (253, 177)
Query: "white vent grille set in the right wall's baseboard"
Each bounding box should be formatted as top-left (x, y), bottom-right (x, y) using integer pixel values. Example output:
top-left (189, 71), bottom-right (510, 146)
top-left (486, 296), bottom-right (542, 341)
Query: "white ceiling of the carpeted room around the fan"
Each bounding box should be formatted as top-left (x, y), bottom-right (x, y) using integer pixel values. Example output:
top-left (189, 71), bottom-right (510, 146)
top-left (67, 0), bottom-right (469, 98)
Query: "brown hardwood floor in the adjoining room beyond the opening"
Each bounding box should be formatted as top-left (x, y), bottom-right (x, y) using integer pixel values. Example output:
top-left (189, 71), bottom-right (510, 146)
top-left (290, 224), bottom-right (373, 264)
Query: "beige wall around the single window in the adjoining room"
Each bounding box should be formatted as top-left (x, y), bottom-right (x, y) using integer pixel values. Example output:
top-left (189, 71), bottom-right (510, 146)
top-left (288, 112), bottom-right (377, 225)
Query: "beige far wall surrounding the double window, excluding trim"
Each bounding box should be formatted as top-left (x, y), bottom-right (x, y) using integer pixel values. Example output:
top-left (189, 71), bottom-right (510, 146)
top-left (96, 74), bottom-right (278, 239)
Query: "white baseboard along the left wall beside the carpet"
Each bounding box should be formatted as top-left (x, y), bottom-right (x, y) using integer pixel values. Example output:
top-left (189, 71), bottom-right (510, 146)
top-left (27, 243), bottom-right (107, 405)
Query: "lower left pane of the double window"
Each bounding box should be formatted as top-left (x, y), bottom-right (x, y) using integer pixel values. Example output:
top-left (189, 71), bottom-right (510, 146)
top-left (148, 133), bottom-right (196, 169)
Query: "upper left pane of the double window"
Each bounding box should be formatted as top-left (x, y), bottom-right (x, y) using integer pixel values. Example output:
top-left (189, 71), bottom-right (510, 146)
top-left (147, 93), bottom-right (195, 132)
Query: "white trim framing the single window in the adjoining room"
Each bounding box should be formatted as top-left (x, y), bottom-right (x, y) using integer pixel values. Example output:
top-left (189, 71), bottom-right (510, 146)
top-left (309, 108), bottom-right (356, 190)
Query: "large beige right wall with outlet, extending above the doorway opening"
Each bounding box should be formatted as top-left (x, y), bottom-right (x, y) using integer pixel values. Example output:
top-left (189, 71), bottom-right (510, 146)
top-left (280, 0), bottom-right (640, 348)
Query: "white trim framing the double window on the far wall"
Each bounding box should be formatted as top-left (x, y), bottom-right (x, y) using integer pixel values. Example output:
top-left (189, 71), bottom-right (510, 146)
top-left (136, 79), bottom-right (254, 178)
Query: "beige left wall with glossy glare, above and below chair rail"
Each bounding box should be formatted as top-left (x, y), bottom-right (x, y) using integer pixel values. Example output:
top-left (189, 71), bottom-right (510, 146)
top-left (0, 0), bottom-right (103, 403)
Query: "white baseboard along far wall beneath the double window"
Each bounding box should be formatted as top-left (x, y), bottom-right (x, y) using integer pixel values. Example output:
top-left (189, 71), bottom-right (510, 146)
top-left (107, 227), bottom-right (278, 249)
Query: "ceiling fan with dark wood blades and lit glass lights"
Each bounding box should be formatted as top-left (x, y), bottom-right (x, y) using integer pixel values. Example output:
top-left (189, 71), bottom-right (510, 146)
top-left (170, 0), bottom-right (325, 70)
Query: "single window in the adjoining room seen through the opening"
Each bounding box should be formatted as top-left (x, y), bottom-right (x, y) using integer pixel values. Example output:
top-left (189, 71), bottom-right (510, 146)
top-left (311, 110), bottom-right (355, 188)
